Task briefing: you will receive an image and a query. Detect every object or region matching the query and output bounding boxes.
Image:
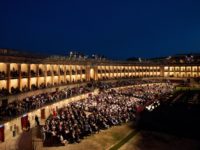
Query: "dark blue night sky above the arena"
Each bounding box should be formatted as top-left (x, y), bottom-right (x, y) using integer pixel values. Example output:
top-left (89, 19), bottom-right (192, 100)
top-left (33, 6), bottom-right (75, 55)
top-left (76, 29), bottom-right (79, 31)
top-left (0, 0), bottom-right (200, 59)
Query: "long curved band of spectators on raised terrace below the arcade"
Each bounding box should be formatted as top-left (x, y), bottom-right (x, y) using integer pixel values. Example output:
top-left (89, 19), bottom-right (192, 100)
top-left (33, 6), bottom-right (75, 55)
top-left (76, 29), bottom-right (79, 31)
top-left (0, 80), bottom-right (170, 120)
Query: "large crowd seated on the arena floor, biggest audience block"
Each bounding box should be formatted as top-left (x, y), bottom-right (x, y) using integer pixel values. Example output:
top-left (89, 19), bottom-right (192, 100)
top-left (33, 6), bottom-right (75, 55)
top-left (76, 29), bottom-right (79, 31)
top-left (42, 83), bottom-right (173, 144)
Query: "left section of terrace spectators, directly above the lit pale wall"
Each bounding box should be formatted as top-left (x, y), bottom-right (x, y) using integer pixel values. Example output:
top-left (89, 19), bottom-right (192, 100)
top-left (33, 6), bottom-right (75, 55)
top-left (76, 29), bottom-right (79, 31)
top-left (0, 86), bottom-right (92, 119)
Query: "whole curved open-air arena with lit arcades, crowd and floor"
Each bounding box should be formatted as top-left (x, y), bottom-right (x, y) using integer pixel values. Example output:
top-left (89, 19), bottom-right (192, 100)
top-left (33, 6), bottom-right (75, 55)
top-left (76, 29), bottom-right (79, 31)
top-left (0, 49), bottom-right (200, 150)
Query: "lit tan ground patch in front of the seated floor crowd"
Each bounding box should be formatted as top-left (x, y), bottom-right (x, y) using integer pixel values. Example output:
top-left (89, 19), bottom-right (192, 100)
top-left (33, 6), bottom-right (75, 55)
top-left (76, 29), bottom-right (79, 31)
top-left (31, 123), bottom-right (134, 150)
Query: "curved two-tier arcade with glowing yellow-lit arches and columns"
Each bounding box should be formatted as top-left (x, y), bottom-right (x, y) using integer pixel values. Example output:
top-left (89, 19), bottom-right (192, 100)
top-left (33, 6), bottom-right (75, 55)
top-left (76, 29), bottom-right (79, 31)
top-left (0, 49), bottom-right (200, 99)
